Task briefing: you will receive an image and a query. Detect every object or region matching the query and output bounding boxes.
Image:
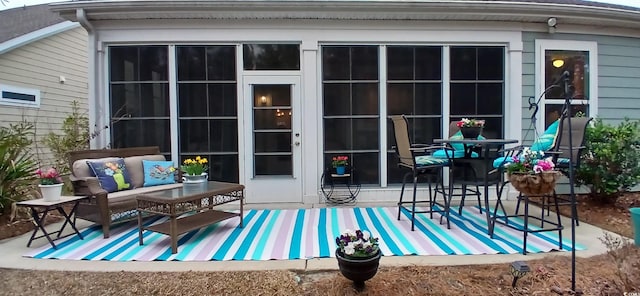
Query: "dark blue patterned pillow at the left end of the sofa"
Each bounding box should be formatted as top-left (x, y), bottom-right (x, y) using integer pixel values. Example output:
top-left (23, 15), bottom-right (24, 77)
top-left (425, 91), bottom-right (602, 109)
top-left (87, 158), bottom-right (133, 192)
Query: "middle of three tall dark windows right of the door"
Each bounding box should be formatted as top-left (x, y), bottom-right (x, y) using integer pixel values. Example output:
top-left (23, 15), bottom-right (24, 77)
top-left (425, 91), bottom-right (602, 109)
top-left (386, 46), bottom-right (442, 183)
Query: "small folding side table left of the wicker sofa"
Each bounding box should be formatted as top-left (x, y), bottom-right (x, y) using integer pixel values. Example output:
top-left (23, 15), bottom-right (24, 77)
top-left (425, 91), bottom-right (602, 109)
top-left (16, 195), bottom-right (87, 249)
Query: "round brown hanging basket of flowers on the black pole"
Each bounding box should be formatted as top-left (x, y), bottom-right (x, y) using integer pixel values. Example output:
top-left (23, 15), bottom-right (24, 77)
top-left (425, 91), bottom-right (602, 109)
top-left (505, 147), bottom-right (559, 196)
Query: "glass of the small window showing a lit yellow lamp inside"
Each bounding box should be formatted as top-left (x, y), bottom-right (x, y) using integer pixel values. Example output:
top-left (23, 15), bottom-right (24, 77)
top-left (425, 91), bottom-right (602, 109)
top-left (545, 50), bottom-right (590, 100)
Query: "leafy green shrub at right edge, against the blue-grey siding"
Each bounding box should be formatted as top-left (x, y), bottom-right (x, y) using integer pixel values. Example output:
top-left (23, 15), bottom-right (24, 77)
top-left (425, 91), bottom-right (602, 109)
top-left (576, 119), bottom-right (640, 199)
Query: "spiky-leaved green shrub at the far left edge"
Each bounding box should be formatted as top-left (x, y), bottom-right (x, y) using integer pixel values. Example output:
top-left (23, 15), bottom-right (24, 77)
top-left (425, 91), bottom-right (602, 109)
top-left (0, 121), bottom-right (38, 214)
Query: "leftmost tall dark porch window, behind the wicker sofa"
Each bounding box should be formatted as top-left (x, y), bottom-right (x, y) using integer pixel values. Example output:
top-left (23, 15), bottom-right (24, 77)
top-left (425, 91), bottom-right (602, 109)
top-left (109, 46), bottom-right (171, 157)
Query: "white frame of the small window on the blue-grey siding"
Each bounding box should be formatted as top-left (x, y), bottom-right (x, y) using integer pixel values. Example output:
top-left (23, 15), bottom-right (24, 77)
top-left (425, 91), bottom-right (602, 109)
top-left (535, 39), bottom-right (598, 130)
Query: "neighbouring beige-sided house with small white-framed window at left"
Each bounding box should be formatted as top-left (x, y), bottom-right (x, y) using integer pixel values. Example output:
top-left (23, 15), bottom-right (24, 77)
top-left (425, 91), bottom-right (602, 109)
top-left (0, 5), bottom-right (88, 166)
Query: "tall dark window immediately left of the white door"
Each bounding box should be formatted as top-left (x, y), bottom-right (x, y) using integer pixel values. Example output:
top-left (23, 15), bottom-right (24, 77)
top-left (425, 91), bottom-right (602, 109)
top-left (176, 46), bottom-right (239, 182)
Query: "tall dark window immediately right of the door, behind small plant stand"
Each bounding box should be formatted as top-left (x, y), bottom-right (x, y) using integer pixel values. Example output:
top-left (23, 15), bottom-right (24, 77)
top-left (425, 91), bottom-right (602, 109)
top-left (322, 46), bottom-right (380, 184)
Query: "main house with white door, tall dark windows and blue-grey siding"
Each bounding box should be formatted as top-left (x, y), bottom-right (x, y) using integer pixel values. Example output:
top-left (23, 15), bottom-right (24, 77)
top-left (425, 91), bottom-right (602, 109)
top-left (51, 0), bottom-right (640, 203)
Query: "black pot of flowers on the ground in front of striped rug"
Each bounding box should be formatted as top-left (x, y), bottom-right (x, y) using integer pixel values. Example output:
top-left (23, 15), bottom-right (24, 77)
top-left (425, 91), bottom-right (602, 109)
top-left (336, 229), bottom-right (381, 291)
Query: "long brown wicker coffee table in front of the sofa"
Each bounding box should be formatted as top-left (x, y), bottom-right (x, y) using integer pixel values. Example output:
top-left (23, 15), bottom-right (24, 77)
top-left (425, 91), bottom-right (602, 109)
top-left (136, 181), bottom-right (244, 254)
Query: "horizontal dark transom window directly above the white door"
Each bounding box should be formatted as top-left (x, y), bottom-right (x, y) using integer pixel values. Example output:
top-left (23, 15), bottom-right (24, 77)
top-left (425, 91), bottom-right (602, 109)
top-left (242, 44), bottom-right (300, 70)
